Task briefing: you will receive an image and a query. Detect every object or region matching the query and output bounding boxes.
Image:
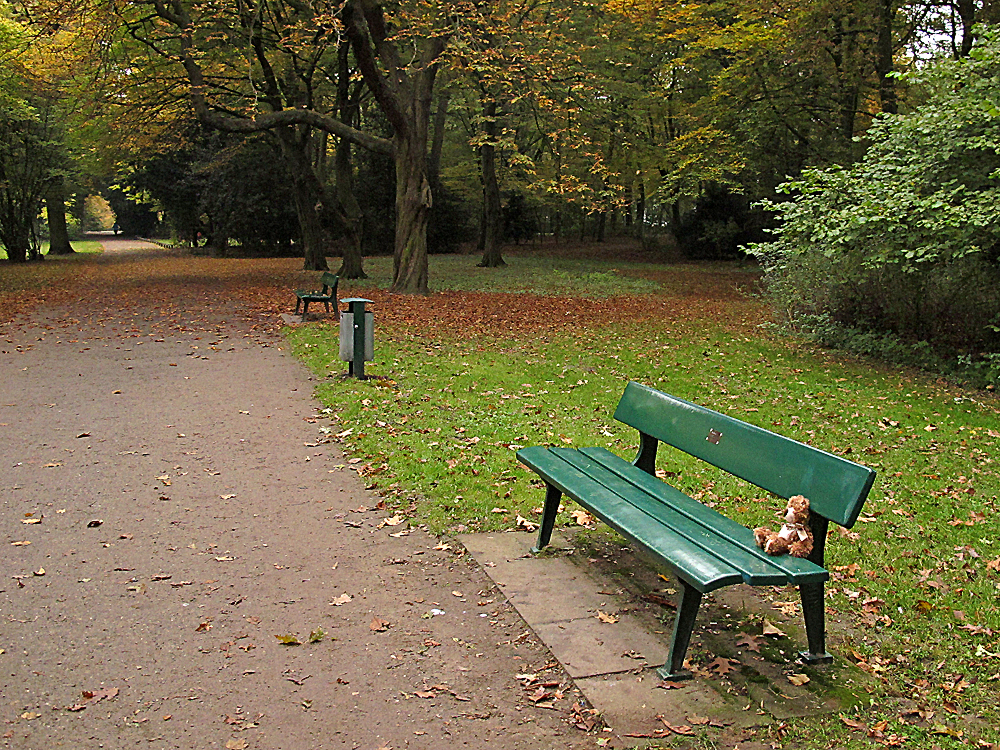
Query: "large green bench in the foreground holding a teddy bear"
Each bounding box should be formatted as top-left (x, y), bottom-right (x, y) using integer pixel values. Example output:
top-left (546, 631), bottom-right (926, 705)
top-left (517, 383), bottom-right (875, 680)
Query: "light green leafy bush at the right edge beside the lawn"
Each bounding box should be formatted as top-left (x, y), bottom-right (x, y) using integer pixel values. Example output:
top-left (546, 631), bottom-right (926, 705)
top-left (751, 28), bottom-right (1000, 380)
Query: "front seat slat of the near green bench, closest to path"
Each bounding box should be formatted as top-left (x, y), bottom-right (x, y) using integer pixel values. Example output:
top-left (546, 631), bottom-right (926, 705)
top-left (518, 446), bottom-right (748, 592)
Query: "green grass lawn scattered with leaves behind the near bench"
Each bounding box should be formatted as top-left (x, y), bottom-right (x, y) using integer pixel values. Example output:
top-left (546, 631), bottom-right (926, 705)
top-left (289, 259), bottom-right (1000, 748)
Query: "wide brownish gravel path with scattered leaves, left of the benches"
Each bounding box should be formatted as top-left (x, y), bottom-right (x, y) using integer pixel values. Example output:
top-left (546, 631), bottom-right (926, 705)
top-left (0, 244), bottom-right (597, 750)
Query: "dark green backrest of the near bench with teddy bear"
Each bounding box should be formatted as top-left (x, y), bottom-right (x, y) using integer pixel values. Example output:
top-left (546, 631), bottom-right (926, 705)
top-left (615, 383), bottom-right (875, 528)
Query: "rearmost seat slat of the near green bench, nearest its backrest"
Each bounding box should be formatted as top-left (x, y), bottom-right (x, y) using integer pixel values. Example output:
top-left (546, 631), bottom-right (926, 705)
top-left (576, 448), bottom-right (830, 586)
